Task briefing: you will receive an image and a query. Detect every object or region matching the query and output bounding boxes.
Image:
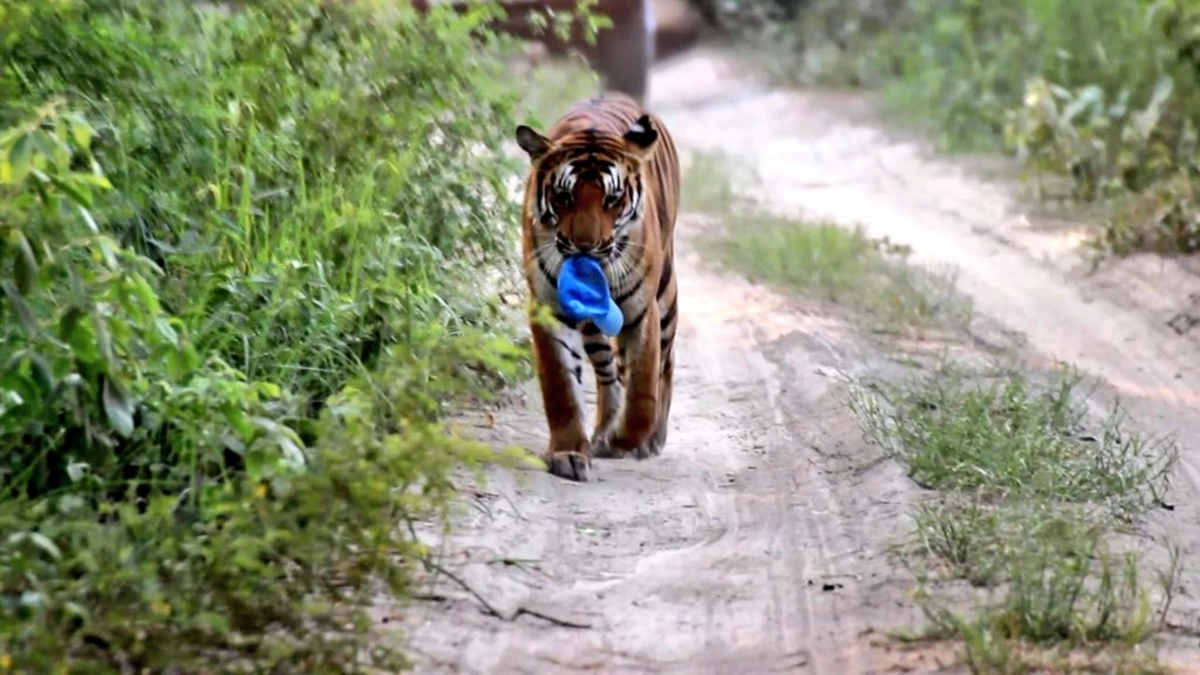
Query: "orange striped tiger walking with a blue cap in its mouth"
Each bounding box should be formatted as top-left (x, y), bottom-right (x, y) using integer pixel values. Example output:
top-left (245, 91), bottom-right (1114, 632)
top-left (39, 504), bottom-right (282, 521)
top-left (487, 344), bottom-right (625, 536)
top-left (516, 92), bottom-right (680, 482)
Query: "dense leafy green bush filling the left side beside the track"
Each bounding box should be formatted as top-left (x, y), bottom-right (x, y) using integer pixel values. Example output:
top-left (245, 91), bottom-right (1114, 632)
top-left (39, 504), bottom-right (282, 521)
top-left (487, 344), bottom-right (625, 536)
top-left (0, 0), bottom-right (540, 674)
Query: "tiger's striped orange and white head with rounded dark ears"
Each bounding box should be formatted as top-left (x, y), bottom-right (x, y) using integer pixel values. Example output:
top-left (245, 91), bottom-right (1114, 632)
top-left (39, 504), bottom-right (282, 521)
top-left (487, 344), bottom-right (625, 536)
top-left (516, 114), bottom-right (659, 262)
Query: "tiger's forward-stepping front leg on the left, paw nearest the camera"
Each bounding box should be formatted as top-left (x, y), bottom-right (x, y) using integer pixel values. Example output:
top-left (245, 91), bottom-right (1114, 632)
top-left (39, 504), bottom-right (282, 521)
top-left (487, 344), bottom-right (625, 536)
top-left (529, 321), bottom-right (592, 482)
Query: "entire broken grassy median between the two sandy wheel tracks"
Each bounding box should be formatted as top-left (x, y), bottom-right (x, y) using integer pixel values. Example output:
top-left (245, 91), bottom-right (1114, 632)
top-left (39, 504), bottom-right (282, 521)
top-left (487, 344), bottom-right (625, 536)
top-left (683, 147), bottom-right (1182, 673)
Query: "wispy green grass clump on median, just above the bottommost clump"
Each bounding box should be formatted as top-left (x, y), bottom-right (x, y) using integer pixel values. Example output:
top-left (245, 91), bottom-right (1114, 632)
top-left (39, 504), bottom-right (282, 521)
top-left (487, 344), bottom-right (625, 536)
top-left (853, 365), bottom-right (1176, 513)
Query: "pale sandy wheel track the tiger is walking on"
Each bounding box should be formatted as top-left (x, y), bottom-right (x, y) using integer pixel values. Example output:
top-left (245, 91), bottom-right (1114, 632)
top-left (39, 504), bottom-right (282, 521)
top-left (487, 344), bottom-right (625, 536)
top-left (398, 225), bottom-right (916, 675)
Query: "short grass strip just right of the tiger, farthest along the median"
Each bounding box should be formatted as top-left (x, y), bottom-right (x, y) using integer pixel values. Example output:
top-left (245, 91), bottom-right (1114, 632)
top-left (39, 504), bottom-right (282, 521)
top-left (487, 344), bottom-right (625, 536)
top-left (683, 150), bottom-right (968, 331)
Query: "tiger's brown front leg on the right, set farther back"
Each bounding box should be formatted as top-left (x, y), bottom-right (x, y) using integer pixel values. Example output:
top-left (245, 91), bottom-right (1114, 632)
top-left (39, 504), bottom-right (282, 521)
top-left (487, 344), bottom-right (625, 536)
top-left (592, 300), bottom-right (660, 459)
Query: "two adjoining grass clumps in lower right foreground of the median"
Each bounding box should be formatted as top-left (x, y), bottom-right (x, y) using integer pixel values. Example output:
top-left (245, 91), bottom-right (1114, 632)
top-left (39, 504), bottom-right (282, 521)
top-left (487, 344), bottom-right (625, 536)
top-left (851, 366), bottom-right (1180, 673)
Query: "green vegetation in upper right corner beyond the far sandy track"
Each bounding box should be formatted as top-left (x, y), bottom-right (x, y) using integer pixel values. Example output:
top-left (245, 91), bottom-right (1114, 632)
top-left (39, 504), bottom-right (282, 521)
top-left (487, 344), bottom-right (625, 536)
top-left (758, 0), bottom-right (1200, 253)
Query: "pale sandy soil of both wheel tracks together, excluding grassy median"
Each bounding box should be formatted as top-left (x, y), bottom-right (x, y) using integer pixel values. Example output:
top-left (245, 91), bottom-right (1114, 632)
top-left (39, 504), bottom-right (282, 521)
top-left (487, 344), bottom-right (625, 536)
top-left (395, 50), bottom-right (1200, 675)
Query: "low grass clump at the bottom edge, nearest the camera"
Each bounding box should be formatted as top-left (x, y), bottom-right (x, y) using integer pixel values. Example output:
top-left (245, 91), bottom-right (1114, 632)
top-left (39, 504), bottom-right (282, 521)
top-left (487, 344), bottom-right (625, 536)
top-left (920, 528), bottom-right (1181, 673)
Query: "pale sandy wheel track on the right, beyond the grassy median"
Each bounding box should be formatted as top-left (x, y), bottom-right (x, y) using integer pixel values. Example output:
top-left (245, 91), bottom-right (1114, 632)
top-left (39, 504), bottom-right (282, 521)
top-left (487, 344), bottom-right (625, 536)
top-left (660, 45), bottom-right (1200, 671)
